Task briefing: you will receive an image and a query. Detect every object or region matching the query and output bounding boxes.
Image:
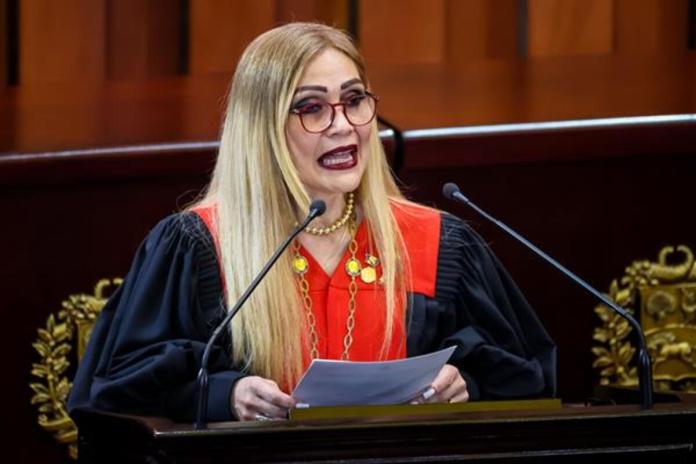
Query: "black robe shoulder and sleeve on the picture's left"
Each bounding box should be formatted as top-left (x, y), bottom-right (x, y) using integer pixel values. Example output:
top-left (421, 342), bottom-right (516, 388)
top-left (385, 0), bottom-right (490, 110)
top-left (68, 213), bottom-right (243, 421)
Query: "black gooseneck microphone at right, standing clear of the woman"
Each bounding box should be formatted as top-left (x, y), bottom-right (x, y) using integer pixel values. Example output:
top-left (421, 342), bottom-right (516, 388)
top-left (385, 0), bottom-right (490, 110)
top-left (442, 182), bottom-right (653, 409)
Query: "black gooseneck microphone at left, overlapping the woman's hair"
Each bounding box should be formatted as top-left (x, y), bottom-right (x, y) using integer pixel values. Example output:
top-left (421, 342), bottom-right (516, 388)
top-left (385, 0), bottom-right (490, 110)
top-left (196, 200), bottom-right (326, 430)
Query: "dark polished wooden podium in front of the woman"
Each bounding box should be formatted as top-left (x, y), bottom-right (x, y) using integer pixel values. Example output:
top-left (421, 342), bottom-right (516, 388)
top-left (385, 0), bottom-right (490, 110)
top-left (76, 403), bottom-right (696, 464)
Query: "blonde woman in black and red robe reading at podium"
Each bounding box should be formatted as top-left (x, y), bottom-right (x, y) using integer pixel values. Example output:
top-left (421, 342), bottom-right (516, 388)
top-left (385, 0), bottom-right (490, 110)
top-left (70, 23), bottom-right (555, 420)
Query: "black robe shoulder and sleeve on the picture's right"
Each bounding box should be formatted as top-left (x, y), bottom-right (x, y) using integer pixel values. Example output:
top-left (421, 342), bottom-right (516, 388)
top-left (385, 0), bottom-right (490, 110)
top-left (408, 213), bottom-right (556, 400)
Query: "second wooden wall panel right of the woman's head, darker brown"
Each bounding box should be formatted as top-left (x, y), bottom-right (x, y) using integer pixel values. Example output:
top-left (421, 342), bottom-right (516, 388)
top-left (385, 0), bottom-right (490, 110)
top-left (445, 0), bottom-right (518, 64)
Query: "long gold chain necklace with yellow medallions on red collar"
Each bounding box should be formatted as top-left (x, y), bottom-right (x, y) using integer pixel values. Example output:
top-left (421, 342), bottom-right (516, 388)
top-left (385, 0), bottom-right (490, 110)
top-left (292, 221), bottom-right (361, 361)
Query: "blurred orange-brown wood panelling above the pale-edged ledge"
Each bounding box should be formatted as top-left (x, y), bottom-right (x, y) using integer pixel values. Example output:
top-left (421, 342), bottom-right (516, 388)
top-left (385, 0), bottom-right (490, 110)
top-left (0, 0), bottom-right (696, 153)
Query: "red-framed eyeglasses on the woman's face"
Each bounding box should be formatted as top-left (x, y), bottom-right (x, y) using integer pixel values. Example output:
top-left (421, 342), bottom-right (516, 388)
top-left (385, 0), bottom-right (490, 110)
top-left (290, 92), bottom-right (379, 134)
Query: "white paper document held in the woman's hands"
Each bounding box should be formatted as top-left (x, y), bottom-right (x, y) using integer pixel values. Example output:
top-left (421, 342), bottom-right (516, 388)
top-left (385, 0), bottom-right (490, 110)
top-left (292, 346), bottom-right (455, 407)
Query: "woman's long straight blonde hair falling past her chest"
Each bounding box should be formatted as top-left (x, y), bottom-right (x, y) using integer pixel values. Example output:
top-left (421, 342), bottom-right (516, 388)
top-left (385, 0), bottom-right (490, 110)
top-left (193, 23), bottom-right (407, 386)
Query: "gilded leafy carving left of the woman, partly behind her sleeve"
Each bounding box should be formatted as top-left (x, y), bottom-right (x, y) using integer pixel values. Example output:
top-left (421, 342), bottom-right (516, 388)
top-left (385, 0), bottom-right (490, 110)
top-left (29, 279), bottom-right (122, 459)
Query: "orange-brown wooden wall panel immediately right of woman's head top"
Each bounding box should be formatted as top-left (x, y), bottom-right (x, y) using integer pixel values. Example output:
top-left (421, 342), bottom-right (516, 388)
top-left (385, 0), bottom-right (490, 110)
top-left (358, 0), bottom-right (447, 64)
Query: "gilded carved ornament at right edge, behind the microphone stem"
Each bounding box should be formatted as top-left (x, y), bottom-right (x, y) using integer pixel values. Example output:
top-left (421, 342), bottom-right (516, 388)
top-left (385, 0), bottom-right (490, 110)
top-left (592, 245), bottom-right (696, 392)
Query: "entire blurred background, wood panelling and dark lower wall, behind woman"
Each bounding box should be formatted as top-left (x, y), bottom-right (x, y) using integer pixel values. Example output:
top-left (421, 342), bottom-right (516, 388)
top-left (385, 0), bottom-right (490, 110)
top-left (0, 0), bottom-right (696, 462)
